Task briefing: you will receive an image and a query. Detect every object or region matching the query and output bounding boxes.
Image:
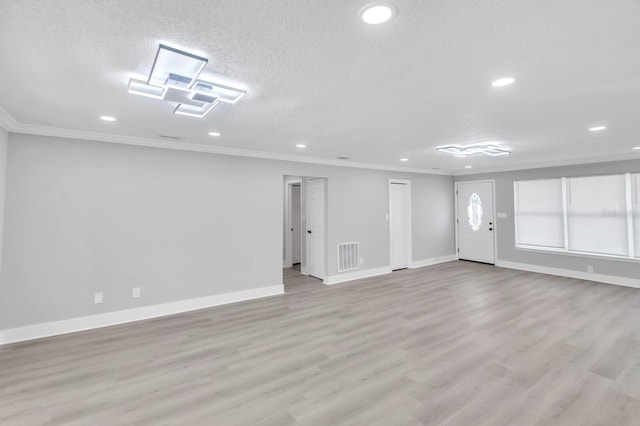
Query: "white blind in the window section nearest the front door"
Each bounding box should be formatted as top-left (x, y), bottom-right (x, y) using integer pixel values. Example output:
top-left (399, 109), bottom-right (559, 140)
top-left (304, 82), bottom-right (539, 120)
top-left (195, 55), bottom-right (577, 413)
top-left (515, 179), bottom-right (564, 248)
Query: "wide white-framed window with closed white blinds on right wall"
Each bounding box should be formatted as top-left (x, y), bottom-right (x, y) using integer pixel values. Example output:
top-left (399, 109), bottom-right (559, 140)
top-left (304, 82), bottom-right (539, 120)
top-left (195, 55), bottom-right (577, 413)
top-left (514, 173), bottom-right (640, 258)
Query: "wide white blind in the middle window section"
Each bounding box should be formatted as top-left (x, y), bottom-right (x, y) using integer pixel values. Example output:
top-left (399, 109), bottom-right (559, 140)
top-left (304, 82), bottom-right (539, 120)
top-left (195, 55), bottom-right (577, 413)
top-left (567, 175), bottom-right (629, 256)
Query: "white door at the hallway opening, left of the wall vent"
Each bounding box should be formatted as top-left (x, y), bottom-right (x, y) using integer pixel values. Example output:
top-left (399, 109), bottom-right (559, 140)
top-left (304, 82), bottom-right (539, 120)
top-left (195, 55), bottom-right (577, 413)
top-left (306, 179), bottom-right (325, 279)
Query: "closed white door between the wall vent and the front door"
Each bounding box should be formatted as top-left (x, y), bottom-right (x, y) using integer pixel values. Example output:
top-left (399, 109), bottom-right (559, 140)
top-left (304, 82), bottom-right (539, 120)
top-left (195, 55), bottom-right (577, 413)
top-left (389, 182), bottom-right (410, 270)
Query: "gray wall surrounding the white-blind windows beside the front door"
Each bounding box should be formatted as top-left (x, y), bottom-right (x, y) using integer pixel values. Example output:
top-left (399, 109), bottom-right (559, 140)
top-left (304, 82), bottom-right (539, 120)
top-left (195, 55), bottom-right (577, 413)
top-left (455, 160), bottom-right (640, 279)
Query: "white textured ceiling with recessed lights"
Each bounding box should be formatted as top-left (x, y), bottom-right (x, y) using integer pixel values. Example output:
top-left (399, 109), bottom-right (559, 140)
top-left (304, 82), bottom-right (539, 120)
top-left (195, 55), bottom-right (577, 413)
top-left (0, 0), bottom-right (640, 174)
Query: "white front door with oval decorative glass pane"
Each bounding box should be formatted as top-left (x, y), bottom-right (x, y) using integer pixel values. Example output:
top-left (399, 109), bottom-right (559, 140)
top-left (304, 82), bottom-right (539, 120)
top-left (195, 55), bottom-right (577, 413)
top-left (456, 182), bottom-right (495, 264)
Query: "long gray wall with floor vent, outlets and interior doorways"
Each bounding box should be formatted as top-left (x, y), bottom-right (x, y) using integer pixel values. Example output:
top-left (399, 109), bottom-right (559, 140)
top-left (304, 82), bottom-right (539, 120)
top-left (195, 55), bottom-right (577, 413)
top-left (0, 134), bottom-right (454, 328)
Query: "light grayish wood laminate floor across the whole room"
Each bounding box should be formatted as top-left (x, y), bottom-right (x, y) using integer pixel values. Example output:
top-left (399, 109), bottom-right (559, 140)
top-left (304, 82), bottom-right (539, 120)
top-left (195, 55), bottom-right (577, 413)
top-left (0, 262), bottom-right (640, 426)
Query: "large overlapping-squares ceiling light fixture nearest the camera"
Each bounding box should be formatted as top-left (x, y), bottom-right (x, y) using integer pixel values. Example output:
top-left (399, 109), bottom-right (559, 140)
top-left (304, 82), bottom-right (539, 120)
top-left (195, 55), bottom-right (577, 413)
top-left (129, 44), bottom-right (247, 118)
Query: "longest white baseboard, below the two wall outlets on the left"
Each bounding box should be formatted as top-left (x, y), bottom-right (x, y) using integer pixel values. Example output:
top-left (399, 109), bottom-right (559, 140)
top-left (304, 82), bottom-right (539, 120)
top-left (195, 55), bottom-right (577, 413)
top-left (0, 285), bottom-right (284, 345)
